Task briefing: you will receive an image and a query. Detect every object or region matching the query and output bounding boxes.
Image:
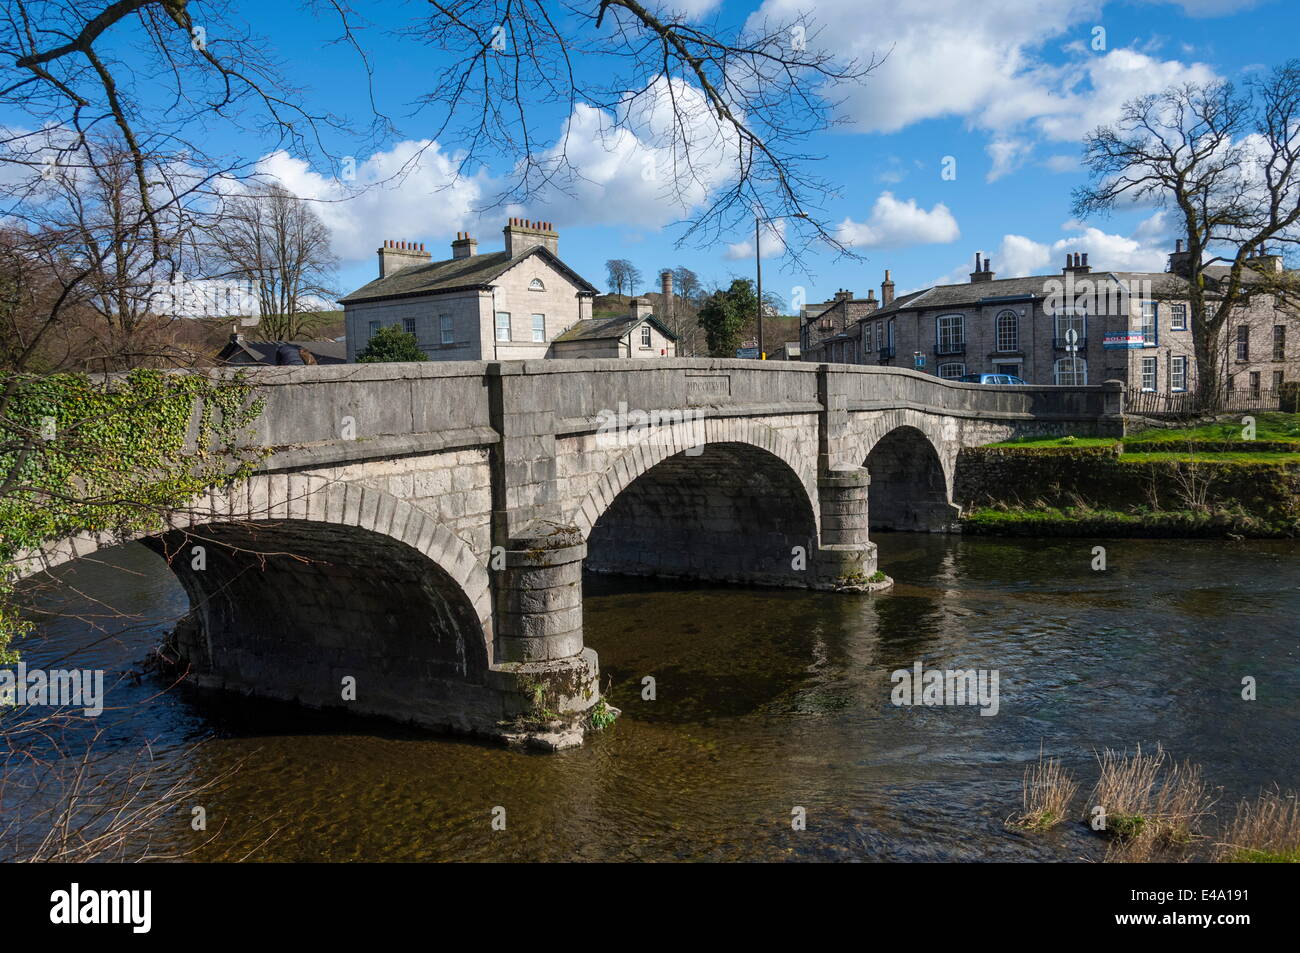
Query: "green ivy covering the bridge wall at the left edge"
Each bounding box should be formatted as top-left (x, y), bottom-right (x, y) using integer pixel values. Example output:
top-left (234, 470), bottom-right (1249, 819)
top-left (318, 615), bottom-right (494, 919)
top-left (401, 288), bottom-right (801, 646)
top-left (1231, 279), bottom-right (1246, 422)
top-left (0, 371), bottom-right (263, 663)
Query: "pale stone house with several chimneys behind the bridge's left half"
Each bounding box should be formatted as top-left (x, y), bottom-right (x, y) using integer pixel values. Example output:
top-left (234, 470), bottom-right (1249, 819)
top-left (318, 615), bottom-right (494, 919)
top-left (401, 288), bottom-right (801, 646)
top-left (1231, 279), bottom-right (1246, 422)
top-left (341, 218), bottom-right (597, 361)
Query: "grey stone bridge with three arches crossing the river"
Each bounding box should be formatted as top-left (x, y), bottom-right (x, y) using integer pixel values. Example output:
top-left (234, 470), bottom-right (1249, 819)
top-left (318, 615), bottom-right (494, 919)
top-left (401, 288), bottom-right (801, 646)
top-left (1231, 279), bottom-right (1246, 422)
top-left (15, 360), bottom-right (1123, 748)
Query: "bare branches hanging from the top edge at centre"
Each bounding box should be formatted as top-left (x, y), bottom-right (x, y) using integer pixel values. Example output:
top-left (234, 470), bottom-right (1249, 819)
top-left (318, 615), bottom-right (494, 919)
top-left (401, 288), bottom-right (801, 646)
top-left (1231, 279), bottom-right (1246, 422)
top-left (410, 0), bottom-right (879, 260)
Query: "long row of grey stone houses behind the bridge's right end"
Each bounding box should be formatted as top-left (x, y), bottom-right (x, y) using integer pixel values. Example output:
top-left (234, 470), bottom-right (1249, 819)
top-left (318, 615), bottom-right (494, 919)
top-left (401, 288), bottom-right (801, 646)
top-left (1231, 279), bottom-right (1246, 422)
top-left (805, 242), bottom-right (1300, 395)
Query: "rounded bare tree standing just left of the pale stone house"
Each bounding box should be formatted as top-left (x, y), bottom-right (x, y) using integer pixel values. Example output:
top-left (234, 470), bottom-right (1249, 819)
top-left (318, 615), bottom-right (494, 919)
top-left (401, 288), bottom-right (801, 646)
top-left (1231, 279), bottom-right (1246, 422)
top-left (209, 185), bottom-right (337, 341)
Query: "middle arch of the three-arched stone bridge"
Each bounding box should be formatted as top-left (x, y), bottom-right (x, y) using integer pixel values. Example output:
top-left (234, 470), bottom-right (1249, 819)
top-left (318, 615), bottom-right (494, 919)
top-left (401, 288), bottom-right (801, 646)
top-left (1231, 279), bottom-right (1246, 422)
top-left (581, 421), bottom-right (818, 585)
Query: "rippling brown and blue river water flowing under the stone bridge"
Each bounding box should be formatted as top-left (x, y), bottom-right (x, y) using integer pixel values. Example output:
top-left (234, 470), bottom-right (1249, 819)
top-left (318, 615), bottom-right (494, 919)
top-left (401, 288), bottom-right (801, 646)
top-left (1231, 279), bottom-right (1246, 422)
top-left (5, 534), bottom-right (1300, 861)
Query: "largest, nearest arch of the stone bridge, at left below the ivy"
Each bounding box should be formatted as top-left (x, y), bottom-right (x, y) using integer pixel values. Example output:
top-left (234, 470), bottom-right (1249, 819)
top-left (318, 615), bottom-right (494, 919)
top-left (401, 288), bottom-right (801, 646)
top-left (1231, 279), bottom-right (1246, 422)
top-left (15, 475), bottom-right (493, 729)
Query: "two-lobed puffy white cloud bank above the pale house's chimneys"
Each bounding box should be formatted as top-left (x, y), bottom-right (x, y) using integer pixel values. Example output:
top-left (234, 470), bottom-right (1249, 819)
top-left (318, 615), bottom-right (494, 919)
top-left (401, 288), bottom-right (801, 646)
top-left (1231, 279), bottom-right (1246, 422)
top-left (250, 78), bottom-right (743, 263)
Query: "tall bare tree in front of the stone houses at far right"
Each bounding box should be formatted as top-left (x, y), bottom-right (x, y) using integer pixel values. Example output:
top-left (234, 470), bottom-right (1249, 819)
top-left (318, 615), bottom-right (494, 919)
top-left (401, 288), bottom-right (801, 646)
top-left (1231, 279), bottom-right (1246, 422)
top-left (1074, 60), bottom-right (1300, 408)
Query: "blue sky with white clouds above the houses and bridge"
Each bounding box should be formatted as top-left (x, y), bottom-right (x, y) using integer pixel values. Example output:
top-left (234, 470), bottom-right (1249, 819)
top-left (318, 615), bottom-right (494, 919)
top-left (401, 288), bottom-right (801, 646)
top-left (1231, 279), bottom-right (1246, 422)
top-left (22, 0), bottom-right (1300, 308)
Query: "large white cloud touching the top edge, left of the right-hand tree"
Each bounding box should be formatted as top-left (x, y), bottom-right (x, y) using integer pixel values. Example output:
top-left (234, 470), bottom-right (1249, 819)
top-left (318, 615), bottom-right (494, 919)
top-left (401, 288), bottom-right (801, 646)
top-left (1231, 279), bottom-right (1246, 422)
top-left (751, 0), bottom-right (1226, 174)
